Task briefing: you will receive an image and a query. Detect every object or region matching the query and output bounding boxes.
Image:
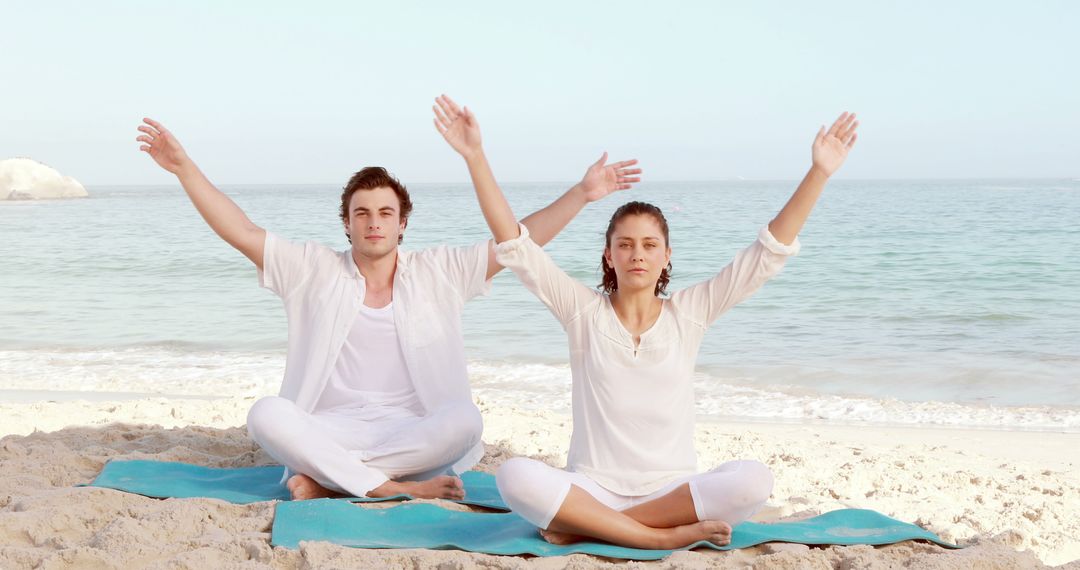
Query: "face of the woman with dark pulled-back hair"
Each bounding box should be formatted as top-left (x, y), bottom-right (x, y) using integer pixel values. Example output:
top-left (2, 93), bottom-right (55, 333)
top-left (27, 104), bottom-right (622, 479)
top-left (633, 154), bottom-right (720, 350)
top-left (604, 214), bottom-right (672, 293)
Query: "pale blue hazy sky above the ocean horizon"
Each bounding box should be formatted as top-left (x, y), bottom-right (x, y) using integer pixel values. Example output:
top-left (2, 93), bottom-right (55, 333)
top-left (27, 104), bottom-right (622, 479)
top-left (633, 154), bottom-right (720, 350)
top-left (0, 0), bottom-right (1080, 187)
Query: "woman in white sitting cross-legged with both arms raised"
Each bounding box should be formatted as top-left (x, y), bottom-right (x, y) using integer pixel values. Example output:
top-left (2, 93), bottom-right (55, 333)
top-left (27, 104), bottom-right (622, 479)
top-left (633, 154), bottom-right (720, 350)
top-left (435, 97), bottom-right (859, 549)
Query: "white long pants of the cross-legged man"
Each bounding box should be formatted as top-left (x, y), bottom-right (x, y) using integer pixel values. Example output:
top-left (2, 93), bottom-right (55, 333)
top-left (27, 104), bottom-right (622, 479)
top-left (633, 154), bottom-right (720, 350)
top-left (247, 396), bottom-right (483, 497)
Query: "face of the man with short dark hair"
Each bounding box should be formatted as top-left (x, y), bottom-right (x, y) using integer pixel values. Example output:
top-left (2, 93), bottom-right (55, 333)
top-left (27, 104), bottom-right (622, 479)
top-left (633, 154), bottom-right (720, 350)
top-left (345, 186), bottom-right (405, 259)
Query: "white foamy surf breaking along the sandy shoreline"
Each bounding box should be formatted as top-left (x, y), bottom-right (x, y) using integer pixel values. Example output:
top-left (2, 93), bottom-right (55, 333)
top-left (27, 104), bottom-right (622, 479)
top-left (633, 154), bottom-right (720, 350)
top-left (0, 343), bottom-right (1080, 432)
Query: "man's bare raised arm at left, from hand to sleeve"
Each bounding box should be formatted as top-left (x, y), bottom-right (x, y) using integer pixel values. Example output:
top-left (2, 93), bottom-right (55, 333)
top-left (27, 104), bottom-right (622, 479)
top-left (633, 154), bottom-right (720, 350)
top-left (136, 119), bottom-right (266, 269)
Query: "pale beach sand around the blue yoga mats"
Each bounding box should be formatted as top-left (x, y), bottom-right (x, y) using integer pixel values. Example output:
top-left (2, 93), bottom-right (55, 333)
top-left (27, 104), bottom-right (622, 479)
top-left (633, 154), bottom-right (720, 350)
top-left (0, 394), bottom-right (1080, 569)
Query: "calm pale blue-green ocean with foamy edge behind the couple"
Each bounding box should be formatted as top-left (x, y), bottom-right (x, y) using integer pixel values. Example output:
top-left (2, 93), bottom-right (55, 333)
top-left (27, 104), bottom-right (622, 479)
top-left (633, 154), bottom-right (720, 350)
top-left (0, 179), bottom-right (1080, 432)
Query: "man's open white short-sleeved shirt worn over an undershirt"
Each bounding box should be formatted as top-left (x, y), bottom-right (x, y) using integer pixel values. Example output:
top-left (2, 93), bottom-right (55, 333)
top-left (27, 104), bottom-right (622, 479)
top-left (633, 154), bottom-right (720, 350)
top-left (258, 232), bottom-right (491, 473)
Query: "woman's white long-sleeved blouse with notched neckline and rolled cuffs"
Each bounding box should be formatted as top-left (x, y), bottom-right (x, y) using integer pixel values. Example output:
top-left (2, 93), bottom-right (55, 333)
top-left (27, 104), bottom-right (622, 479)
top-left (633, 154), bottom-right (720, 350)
top-left (496, 226), bottom-right (799, 496)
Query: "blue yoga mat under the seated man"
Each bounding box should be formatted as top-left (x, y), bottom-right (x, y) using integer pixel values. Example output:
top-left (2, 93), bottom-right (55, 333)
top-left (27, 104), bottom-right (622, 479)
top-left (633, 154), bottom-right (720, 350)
top-left (89, 460), bottom-right (510, 511)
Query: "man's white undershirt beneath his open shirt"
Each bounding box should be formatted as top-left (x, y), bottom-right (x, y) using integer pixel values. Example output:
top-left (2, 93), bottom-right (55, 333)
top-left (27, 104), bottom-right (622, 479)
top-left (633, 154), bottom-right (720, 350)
top-left (315, 302), bottom-right (423, 420)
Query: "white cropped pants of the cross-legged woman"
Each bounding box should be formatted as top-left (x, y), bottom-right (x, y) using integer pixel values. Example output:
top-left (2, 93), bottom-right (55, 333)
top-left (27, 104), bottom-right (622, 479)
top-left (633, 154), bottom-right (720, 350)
top-left (495, 458), bottom-right (772, 529)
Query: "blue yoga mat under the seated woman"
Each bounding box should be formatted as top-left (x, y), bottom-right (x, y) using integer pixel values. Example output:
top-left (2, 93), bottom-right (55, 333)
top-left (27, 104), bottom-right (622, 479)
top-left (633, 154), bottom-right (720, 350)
top-left (270, 499), bottom-right (957, 560)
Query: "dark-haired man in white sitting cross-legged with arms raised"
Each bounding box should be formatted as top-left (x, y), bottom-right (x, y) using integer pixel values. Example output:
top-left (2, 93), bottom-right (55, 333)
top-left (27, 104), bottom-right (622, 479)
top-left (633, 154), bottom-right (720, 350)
top-left (137, 96), bottom-right (640, 500)
